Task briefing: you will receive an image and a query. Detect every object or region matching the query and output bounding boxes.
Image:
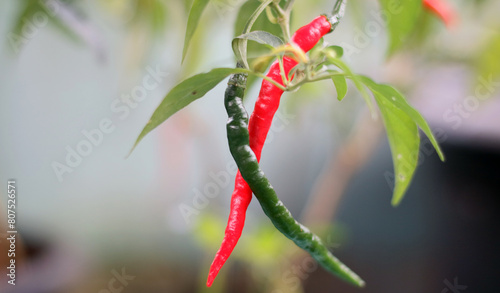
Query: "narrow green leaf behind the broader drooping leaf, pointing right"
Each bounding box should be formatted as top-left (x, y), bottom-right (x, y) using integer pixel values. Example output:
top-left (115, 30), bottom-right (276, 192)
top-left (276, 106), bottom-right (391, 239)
top-left (360, 76), bottom-right (445, 161)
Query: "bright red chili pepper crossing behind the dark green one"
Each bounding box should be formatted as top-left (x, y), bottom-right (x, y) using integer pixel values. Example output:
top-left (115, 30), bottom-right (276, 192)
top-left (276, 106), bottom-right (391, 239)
top-left (207, 16), bottom-right (332, 287)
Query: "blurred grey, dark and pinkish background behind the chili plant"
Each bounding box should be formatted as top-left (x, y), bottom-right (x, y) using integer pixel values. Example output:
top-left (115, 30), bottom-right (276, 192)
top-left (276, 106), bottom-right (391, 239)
top-left (0, 0), bottom-right (500, 293)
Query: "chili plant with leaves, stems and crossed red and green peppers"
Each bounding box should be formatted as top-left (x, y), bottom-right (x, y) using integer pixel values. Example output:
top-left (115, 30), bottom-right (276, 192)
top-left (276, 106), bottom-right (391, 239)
top-left (133, 0), bottom-right (456, 287)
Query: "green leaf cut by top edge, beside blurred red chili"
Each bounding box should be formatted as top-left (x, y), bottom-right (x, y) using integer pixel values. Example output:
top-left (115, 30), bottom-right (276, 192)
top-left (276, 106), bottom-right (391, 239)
top-left (380, 0), bottom-right (422, 56)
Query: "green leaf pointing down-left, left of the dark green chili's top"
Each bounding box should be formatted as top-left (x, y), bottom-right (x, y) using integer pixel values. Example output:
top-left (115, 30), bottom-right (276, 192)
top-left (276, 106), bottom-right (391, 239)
top-left (130, 68), bottom-right (246, 153)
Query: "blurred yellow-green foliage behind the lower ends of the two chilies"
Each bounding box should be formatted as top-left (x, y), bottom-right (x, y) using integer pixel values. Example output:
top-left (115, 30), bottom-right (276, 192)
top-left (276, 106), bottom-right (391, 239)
top-left (193, 213), bottom-right (348, 292)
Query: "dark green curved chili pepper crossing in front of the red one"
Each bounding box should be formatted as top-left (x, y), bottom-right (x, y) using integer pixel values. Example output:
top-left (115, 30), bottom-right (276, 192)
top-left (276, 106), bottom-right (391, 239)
top-left (224, 63), bottom-right (365, 287)
